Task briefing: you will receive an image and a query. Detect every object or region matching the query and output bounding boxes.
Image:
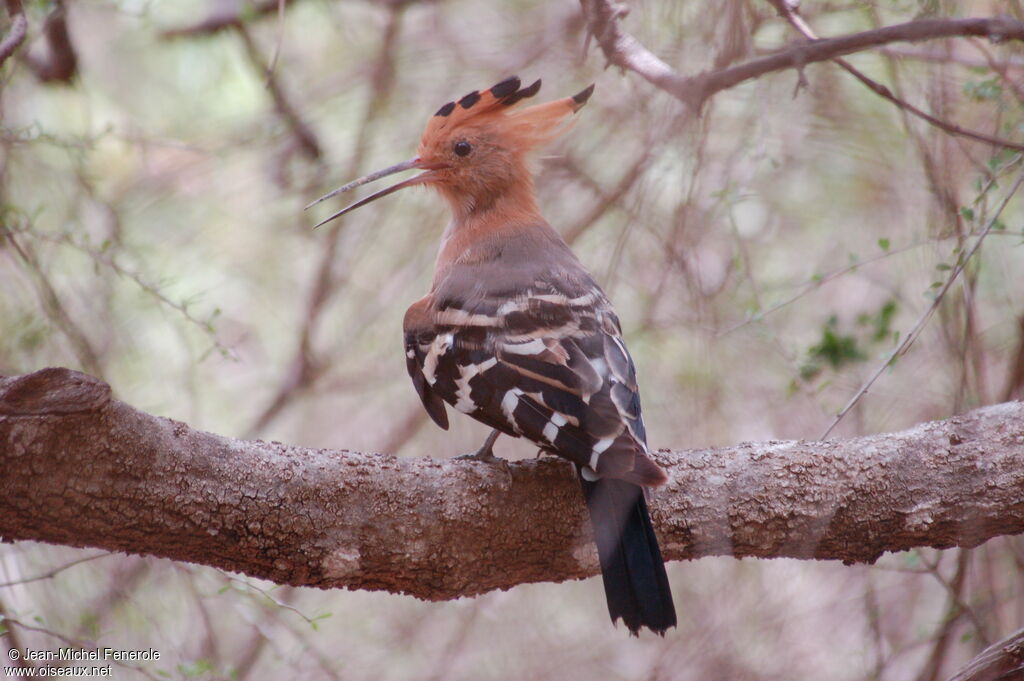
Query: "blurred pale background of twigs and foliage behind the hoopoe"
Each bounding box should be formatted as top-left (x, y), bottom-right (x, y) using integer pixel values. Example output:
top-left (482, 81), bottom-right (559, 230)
top-left (0, 0), bottom-right (1024, 681)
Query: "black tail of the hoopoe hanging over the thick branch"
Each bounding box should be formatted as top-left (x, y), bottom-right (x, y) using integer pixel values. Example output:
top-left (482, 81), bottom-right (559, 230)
top-left (580, 475), bottom-right (676, 636)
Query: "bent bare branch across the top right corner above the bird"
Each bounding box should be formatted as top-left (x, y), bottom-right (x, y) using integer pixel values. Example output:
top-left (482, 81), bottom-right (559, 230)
top-left (582, 0), bottom-right (1024, 109)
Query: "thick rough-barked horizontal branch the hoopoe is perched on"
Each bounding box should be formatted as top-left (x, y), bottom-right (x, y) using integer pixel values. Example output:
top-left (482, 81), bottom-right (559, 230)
top-left (0, 369), bottom-right (1024, 599)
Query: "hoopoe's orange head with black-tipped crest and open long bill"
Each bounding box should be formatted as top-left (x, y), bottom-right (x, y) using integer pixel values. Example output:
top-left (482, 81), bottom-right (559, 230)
top-left (307, 77), bottom-right (594, 226)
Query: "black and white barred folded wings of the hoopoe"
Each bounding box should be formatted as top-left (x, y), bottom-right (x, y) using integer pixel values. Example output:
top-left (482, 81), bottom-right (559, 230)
top-left (406, 288), bottom-right (665, 484)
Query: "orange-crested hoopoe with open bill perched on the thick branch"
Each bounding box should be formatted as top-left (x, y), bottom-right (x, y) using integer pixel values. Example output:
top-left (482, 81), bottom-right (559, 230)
top-left (307, 76), bottom-right (676, 636)
